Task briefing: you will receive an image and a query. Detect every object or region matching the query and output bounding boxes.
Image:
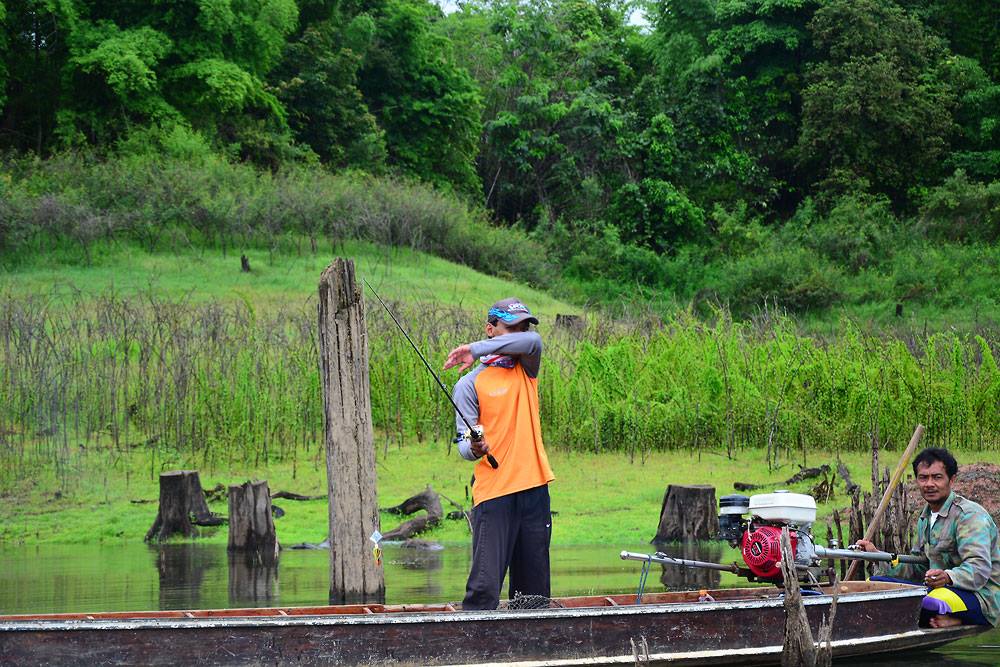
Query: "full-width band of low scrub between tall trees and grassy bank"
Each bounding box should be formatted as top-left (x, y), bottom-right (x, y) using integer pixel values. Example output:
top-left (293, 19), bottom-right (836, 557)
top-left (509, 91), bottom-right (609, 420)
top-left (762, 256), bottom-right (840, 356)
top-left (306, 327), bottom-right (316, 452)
top-left (0, 153), bottom-right (1000, 332)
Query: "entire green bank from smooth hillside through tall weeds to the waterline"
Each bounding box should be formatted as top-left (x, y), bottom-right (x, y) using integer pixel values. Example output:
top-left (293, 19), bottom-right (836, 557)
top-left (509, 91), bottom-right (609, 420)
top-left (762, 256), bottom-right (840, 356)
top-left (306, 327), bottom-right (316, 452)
top-left (0, 231), bottom-right (1000, 544)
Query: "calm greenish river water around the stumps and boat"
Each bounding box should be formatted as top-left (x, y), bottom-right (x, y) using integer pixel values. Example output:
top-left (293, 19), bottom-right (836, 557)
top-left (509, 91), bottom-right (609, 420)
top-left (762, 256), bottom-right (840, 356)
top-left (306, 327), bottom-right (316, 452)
top-left (0, 544), bottom-right (1000, 667)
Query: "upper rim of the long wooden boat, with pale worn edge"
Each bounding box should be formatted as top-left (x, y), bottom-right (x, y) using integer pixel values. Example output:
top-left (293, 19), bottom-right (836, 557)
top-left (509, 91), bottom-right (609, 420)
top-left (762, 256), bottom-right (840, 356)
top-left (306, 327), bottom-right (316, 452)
top-left (0, 584), bottom-right (926, 632)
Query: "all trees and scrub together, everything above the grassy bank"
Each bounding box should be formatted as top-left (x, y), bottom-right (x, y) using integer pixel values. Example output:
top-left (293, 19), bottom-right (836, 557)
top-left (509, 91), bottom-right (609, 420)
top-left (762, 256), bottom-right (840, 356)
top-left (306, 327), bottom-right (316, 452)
top-left (0, 0), bottom-right (1000, 320)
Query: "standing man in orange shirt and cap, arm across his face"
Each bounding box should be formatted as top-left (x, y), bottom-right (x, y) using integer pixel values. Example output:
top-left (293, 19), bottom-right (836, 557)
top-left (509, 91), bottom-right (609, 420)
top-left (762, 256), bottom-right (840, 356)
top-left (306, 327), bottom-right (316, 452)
top-left (444, 298), bottom-right (554, 610)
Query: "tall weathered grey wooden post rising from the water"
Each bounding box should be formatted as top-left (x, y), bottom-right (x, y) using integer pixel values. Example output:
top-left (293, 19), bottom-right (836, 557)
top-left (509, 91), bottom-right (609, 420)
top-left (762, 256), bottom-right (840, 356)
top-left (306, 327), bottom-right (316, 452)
top-left (319, 258), bottom-right (385, 604)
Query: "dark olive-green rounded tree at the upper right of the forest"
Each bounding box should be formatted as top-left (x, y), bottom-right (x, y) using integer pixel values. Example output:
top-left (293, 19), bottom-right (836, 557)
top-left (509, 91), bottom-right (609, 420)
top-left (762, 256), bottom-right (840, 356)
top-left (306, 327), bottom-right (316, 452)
top-left (798, 0), bottom-right (956, 205)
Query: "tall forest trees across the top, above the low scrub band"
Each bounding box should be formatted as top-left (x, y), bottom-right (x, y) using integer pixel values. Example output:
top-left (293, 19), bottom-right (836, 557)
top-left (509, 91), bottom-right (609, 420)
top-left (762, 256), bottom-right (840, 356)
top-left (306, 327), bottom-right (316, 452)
top-left (0, 0), bottom-right (1000, 255)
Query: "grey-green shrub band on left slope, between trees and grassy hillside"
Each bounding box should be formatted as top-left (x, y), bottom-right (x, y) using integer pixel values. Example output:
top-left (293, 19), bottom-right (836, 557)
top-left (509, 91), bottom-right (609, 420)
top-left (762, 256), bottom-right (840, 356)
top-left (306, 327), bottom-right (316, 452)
top-left (0, 157), bottom-right (554, 285)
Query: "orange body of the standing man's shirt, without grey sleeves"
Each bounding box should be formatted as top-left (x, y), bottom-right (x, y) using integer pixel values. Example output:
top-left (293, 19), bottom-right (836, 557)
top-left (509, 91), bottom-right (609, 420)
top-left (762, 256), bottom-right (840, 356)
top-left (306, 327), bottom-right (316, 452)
top-left (472, 364), bottom-right (555, 505)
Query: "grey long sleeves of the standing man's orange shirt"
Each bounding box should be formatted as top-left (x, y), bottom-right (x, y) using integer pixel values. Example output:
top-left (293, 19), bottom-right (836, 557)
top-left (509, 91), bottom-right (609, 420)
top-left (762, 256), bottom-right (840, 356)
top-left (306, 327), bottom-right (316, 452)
top-left (452, 331), bottom-right (542, 461)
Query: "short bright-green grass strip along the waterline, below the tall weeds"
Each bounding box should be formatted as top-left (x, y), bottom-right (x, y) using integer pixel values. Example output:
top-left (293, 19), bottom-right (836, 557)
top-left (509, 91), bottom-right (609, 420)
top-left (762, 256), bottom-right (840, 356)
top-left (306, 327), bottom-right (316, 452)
top-left (0, 440), bottom-right (1000, 546)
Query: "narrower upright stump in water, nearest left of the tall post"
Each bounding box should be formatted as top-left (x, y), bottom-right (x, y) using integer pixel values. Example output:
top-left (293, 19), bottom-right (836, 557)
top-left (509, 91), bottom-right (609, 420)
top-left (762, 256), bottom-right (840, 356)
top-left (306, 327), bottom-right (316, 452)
top-left (229, 481), bottom-right (280, 564)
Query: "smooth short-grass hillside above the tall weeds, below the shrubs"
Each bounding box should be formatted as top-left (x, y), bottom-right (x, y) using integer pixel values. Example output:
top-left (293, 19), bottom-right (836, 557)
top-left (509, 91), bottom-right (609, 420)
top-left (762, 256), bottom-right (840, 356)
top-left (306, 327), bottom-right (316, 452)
top-left (0, 240), bottom-right (580, 322)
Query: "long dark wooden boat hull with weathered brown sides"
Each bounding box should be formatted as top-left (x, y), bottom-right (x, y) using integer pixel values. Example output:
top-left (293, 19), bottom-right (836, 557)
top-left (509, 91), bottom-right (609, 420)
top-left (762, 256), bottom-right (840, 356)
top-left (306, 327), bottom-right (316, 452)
top-left (0, 582), bottom-right (976, 666)
